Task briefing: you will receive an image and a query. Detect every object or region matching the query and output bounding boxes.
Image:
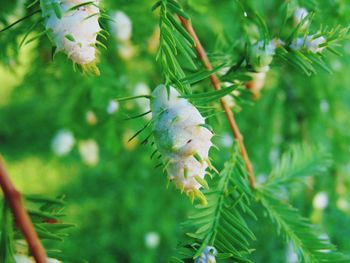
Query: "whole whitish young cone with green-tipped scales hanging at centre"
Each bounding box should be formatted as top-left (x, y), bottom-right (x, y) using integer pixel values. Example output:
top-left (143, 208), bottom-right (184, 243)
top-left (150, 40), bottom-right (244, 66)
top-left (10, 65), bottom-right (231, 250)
top-left (151, 85), bottom-right (213, 203)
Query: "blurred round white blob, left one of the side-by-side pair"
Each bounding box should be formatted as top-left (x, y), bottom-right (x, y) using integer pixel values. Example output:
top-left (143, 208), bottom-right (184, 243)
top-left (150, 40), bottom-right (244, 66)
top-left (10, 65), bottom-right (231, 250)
top-left (51, 130), bottom-right (75, 156)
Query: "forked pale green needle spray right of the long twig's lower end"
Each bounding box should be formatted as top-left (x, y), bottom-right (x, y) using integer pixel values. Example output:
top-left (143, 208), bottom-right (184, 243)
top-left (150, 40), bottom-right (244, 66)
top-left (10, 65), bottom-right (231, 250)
top-left (257, 148), bottom-right (349, 263)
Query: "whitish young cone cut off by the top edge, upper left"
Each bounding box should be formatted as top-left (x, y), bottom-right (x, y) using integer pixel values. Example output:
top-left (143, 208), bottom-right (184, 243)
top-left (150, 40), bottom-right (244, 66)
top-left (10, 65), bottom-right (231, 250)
top-left (41, 0), bottom-right (101, 68)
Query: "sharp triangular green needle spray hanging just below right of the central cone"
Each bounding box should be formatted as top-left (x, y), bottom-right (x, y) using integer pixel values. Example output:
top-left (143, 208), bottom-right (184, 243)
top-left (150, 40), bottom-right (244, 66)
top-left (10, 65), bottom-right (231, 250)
top-left (174, 152), bottom-right (255, 262)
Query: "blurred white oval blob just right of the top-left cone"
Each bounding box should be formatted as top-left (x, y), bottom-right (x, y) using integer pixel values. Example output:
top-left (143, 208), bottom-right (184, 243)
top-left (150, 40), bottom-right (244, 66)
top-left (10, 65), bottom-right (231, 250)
top-left (110, 11), bottom-right (132, 42)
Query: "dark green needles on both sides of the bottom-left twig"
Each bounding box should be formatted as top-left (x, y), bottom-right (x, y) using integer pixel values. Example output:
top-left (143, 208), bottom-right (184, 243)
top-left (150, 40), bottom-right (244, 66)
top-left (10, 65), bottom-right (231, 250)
top-left (0, 196), bottom-right (75, 263)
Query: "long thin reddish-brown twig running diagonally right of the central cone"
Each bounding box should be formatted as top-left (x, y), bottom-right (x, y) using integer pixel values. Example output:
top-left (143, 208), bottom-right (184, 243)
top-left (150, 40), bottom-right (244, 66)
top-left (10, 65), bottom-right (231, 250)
top-left (179, 16), bottom-right (256, 188)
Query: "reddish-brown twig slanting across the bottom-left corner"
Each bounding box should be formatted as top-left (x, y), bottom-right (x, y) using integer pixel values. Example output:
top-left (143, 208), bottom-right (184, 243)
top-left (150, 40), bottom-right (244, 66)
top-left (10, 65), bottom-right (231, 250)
top-left (0, 155), bottom-right (47, 263)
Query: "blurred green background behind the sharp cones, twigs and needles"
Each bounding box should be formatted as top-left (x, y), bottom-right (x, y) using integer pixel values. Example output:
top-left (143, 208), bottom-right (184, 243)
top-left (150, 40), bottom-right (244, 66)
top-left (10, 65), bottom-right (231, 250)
top-left (0, 0), bottom-right (350, 263)
